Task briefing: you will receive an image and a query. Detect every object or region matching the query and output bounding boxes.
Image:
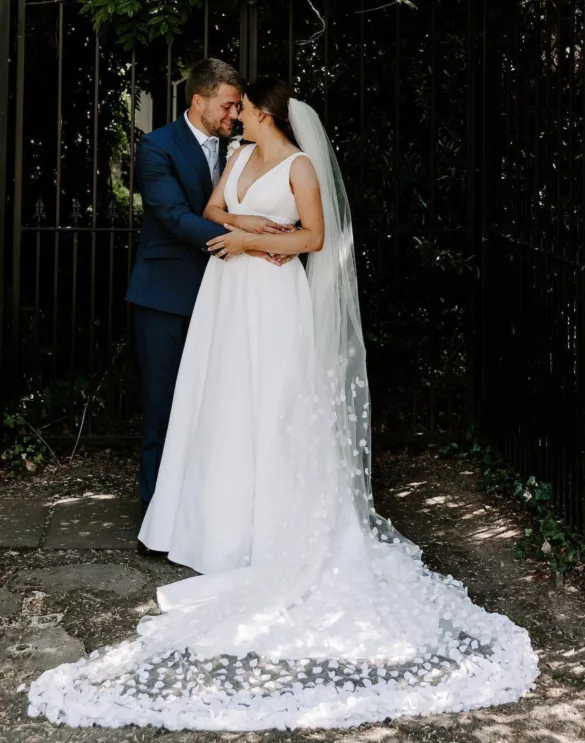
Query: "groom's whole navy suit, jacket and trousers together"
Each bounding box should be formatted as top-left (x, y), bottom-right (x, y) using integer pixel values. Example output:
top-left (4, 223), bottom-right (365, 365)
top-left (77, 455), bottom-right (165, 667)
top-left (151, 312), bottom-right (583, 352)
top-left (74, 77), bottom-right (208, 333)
top-left (126, 115), bottom-right (225, 513)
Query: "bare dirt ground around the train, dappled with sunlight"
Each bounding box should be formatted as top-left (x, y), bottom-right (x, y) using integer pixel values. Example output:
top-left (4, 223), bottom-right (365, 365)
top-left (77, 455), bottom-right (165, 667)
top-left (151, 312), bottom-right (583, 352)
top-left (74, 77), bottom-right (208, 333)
top-left (0, 449), bottom-right (585, 743)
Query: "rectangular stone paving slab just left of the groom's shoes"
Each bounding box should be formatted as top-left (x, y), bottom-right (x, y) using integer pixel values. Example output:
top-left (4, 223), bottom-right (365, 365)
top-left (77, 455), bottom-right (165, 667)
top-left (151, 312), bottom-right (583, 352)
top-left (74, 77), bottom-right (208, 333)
top-left (44, 496), bottom-right (142, 549)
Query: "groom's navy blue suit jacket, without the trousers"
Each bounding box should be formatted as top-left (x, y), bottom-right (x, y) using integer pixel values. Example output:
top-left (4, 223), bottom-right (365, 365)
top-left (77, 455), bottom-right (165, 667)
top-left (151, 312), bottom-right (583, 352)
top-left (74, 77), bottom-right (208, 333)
top-left (126, 114), bottom-right (225, 315)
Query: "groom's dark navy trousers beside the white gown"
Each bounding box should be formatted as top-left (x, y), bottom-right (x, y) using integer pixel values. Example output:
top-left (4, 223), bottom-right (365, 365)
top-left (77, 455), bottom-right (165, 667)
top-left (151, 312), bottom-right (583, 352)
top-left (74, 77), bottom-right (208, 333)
top-left (134, 305), bottom-right (191, 513)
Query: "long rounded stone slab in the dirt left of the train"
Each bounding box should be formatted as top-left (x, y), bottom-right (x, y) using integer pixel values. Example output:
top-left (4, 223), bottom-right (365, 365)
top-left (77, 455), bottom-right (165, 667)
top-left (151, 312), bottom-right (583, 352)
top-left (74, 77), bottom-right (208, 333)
top-left (9, 563), bottom-right (146, 596)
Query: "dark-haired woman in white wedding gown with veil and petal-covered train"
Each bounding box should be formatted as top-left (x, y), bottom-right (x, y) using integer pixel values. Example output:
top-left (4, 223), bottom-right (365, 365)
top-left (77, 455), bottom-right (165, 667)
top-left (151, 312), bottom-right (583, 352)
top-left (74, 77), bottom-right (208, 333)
top-left (29, 81), bottom-right (538, 731)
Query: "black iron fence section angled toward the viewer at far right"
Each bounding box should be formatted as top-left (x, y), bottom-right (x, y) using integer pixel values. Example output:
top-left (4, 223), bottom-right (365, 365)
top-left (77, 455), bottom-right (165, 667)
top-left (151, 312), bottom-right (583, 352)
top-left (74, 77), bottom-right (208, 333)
top-left (481, 0), bottom-right (585, 531)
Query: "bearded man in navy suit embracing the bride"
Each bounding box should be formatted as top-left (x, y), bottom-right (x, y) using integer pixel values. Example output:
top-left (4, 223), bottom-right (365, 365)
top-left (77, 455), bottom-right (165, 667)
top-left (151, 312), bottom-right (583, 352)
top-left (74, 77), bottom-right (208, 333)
top-left (126, 59), bottom-right (244, 554)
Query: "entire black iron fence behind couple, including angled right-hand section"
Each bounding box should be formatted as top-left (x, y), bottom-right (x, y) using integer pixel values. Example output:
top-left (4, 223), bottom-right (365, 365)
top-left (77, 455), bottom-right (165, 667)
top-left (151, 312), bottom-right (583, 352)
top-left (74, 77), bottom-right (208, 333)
top-left (0, 0), bottom-right (585, 531)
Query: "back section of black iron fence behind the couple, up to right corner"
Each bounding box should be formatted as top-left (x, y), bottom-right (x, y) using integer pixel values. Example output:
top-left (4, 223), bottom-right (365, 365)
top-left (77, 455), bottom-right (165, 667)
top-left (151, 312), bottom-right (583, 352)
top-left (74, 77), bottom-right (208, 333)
top-left (0, 0), bottom-right (481, 448)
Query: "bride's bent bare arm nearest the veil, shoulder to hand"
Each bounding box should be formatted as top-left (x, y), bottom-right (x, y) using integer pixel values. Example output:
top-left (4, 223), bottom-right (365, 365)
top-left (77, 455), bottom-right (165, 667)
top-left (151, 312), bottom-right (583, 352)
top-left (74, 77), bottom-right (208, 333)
top-left (208, 157), bottom-right (325, 258)
